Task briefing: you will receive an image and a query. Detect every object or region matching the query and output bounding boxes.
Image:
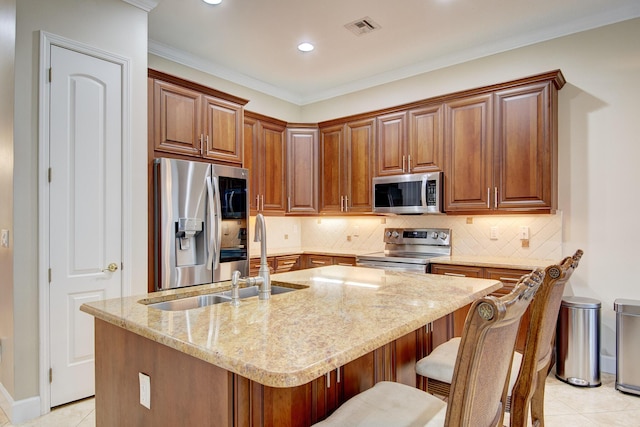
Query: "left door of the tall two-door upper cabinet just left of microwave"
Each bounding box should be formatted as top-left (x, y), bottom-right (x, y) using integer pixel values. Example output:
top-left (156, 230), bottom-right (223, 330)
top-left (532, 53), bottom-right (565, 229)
top-left (320, 125), bottom-right (346, 212)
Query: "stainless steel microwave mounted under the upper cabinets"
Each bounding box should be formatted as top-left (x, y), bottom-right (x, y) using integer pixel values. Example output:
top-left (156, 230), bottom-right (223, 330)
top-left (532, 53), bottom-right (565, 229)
top-left (372, 172), bottom-right (443, 215)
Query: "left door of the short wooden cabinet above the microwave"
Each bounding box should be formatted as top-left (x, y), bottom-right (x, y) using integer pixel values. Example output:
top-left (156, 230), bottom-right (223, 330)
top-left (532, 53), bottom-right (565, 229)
top-left (377, 113), bottom-right (407, 176)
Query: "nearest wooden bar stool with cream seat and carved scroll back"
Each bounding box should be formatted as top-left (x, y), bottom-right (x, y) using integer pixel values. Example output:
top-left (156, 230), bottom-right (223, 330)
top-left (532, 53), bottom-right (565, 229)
top-left (315, 270), bottom-right (544, 427)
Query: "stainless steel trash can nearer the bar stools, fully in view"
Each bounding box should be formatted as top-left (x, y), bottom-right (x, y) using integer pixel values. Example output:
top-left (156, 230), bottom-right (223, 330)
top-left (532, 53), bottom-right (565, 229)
top-left (556, 297), bottom-right (602, 387)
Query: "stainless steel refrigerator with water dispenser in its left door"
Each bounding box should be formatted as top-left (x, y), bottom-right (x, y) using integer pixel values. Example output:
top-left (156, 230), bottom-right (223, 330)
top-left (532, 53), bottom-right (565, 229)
top-left (154, 159), bottom-right (249, 290)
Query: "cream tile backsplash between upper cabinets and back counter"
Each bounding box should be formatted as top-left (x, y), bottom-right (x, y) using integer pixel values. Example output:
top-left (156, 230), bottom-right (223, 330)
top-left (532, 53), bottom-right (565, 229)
top-left (250, 213), bottom-right (562, 259)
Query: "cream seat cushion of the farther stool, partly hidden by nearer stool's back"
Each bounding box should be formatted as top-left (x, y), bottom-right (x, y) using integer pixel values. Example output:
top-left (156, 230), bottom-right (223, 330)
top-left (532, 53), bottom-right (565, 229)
top-left (416, 337), bottom-right (522, 395)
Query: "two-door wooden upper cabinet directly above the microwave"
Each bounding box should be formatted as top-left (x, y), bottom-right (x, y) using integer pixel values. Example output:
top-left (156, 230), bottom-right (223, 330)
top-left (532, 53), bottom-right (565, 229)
top-left (376, 104), bottom-right (443, 176)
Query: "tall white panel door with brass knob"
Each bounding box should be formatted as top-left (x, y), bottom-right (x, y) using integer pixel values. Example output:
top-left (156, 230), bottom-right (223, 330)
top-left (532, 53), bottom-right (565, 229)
top-left (48, 45), bottom-right (122, 407)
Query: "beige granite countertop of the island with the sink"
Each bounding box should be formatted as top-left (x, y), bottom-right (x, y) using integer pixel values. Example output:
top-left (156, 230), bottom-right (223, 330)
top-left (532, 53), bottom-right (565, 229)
top-left (80, 265), bottom-right (501, 387)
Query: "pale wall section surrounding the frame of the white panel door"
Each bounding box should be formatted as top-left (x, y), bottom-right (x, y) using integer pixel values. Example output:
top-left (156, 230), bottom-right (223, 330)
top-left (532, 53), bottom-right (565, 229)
top-left (0, 0), bottom-right (147, 412)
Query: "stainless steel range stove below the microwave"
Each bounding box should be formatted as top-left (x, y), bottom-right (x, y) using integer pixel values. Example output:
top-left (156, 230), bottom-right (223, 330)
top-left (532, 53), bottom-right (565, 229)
top-left (356, 228), bottom-right (451, 273)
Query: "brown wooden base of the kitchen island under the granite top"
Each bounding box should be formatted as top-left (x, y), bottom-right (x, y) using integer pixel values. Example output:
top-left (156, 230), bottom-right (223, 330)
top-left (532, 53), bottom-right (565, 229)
top-left (95, 319), bottom-right (456, 427)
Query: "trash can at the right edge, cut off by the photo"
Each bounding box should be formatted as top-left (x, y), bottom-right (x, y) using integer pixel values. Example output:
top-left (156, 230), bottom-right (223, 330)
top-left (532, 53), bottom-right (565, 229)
top-left (613, 299), bottom-right (640, 395)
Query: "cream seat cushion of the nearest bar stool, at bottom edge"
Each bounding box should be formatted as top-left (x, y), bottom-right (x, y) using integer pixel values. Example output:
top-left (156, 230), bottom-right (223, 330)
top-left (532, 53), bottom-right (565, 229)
top-left (315, 381), bottom-right (447, 427)
